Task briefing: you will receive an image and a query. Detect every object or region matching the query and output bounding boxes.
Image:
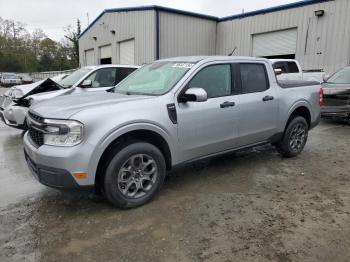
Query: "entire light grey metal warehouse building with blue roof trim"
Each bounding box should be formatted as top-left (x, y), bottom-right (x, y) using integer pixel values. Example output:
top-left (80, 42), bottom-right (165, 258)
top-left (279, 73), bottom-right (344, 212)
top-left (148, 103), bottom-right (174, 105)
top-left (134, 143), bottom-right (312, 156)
top-left (79, 0), bottom-right (350, 73)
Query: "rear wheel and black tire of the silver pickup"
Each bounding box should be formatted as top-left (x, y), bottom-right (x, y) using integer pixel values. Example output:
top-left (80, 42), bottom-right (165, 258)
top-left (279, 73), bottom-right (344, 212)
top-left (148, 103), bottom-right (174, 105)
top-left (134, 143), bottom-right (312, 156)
top-left (276, 116), bottom-right (309, 157)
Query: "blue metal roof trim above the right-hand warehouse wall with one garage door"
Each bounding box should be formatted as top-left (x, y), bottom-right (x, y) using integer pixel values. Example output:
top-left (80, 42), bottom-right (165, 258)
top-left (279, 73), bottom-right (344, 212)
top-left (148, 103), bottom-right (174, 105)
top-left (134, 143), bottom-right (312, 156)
top-left (219, 0), bottom-right (334, 22)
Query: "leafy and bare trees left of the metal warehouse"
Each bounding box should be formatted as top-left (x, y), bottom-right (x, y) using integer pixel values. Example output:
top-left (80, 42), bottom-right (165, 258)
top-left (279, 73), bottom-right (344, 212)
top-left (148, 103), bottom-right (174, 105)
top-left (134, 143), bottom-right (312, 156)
top-left (0, 17), bottom-right (81, 72)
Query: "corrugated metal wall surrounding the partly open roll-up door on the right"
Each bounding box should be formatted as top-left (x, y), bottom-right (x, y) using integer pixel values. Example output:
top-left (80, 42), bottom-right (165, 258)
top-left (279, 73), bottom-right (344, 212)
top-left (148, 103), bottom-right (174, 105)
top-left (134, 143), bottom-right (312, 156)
top-left (216, 0), bottom-right (350, 73)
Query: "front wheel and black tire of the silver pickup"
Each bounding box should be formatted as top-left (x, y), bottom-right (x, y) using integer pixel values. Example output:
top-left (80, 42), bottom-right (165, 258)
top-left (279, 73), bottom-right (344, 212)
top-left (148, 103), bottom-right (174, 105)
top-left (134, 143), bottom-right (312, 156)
top-left (103, 142), bottom-right (166, 208)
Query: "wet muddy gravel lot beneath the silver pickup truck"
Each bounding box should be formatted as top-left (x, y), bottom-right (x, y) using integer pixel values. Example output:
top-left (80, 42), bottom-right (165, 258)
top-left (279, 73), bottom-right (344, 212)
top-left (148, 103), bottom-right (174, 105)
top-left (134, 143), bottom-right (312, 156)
top-left (0, 87), bottom-right (350, 261)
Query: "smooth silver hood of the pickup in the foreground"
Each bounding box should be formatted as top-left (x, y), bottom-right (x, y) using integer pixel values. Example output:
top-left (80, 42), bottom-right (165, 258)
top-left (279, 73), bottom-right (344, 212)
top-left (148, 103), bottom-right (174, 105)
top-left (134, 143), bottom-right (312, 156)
top-left (30, 92), bottom-right (154, 119)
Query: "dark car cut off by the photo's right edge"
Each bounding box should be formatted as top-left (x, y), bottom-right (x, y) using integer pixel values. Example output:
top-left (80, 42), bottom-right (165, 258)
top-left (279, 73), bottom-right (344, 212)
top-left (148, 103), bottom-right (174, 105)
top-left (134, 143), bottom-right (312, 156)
top-left (321, 66), bottom-right (350, 120)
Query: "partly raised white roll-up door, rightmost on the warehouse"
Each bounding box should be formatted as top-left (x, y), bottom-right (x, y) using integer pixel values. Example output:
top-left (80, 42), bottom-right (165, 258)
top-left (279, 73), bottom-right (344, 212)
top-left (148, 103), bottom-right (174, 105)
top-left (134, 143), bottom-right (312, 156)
top-left (253, 28), bottom-right (298, 57)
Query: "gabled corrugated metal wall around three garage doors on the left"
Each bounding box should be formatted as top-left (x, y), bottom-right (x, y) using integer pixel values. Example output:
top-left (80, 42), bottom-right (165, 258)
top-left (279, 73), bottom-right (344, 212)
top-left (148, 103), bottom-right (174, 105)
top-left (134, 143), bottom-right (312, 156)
top-left (79, 10), bottom-right (156, 66)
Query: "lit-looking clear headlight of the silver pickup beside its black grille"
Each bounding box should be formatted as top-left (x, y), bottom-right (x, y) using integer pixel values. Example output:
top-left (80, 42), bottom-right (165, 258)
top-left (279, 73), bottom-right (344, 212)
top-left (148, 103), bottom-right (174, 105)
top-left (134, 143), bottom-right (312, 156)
top-left (44, 119), bottom-right (83, 146)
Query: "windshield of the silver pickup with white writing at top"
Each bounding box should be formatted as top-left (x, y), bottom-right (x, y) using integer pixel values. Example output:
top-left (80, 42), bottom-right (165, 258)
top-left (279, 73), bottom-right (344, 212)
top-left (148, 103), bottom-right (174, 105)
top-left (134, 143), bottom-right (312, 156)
top-left (114, 62), bottom-right (194, 95)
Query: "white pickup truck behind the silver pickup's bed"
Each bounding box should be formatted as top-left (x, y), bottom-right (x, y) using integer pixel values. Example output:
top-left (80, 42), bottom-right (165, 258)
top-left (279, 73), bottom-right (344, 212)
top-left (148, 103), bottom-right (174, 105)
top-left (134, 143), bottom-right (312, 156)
top-left (271, 59), bottom-right (325, 83)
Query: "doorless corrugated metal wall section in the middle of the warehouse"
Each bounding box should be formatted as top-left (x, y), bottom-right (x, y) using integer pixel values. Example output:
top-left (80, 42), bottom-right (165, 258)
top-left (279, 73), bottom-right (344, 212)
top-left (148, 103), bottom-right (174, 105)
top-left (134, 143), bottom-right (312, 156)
top-left (159, 11), bottom-right (216, 58)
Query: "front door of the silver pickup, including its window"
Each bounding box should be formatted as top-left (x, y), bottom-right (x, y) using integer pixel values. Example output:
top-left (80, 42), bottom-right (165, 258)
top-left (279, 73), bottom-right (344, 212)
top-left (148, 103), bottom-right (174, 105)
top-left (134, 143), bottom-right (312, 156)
top-left (177, 64), bottom-right (237, 162)
